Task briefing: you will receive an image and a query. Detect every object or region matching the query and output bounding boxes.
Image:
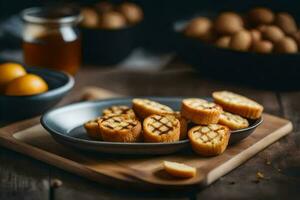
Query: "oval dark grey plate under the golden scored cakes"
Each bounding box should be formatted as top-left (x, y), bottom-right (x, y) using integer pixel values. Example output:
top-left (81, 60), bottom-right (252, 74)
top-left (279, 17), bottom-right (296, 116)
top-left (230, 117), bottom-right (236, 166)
top-left (41, 97), bottom-right (262, 155)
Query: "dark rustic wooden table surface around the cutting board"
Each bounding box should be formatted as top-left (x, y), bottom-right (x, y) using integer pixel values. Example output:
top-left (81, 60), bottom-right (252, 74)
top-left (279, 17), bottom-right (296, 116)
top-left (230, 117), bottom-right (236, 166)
top-left (0, 63), bottom-right (300, 200)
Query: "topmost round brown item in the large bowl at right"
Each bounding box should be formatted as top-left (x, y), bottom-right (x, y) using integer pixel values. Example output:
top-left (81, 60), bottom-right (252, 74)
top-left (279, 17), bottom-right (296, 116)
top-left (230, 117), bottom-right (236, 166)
top-left (248, 7), bottom-right (274, 25)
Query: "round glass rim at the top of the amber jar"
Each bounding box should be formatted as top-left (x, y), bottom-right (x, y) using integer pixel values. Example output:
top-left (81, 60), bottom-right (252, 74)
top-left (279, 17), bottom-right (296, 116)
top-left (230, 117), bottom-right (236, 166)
top-left (21, 7), bottom-right (82, 24)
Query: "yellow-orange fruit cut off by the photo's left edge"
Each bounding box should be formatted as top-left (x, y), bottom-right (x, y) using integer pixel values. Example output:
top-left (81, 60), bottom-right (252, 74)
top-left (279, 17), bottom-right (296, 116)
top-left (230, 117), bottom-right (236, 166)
top-left (0, 63), bottom-right (26, 91)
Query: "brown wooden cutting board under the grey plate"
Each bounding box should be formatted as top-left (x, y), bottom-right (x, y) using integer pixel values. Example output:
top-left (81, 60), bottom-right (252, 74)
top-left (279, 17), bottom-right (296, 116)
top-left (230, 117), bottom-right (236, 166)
top-left (0, 88), bottom-right (292, 189)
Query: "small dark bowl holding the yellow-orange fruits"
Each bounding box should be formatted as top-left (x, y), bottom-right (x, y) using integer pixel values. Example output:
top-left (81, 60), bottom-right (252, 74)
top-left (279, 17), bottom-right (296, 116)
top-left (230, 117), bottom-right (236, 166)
top-left (0, 67), bottom-right (74, 122)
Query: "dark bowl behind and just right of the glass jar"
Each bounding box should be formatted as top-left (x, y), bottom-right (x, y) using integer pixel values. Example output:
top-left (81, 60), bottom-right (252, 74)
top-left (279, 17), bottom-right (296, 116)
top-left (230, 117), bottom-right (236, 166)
top-left (81, 23), bottom-right (141, 65)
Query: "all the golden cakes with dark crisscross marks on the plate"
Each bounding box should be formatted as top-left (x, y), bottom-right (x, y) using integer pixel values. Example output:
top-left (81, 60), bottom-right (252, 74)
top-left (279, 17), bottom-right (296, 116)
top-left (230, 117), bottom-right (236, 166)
top-left (84, 91), bottom-right (263, 156)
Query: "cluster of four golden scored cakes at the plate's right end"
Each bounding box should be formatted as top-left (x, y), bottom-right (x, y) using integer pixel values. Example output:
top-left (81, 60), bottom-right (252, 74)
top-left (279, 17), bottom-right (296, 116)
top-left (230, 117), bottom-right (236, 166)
top-left (181, 91), bottom-right (263, 156)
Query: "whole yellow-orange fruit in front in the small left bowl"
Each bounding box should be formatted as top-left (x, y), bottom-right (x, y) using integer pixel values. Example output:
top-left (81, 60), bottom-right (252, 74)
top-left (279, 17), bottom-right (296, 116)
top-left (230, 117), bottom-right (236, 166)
top-left (5, 74), bottom-right (48, 96)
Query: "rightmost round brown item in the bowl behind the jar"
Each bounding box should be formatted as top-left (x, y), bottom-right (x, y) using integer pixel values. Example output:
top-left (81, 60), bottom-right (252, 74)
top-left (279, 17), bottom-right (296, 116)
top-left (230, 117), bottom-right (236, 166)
top-left (118, 2), bottom-right (144, 24)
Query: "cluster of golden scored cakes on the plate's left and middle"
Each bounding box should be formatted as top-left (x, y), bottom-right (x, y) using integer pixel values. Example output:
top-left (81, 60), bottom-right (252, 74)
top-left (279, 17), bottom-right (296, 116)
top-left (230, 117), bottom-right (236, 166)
top-left (84, 99), bottom-right (187, 142)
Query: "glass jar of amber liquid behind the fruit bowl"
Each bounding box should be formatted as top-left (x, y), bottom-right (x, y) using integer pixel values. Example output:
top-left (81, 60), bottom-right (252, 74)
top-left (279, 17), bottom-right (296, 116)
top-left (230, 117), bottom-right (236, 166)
top-left (22, 7), bottom-right (81, 75)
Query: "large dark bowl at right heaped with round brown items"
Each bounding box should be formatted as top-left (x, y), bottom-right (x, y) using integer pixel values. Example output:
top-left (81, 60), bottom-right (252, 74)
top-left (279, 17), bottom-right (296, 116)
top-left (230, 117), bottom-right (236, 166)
top-left (173, 20), bottom-right (300, 89)
